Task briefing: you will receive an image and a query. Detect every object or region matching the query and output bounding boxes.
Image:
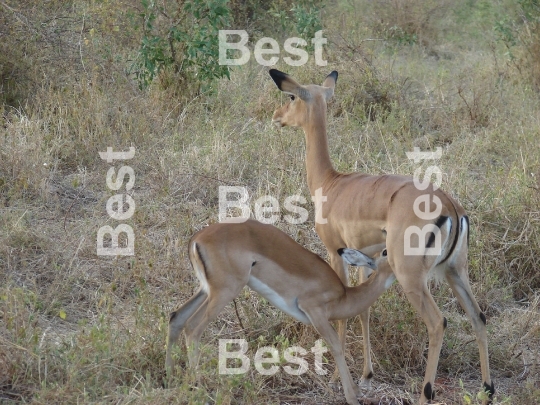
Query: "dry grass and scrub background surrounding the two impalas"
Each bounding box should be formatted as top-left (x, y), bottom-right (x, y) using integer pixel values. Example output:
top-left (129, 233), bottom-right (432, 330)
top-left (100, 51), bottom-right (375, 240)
top-left (0, 0), bottom-right (540, 404)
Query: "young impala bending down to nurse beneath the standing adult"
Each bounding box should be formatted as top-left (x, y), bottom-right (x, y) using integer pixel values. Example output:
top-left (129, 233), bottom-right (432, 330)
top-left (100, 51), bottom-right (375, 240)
top-left (165, 220), bottom-right (395, 405)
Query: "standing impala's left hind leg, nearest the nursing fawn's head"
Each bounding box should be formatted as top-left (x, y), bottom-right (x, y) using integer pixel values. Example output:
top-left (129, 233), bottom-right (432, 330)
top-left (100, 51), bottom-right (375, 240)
top-left (397, 272), bottom-right (446, 405)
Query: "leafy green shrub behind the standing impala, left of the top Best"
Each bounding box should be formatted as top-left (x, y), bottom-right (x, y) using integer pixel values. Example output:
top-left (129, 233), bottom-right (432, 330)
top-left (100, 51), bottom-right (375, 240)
top-left (132, 0), bottom-right (231, 88)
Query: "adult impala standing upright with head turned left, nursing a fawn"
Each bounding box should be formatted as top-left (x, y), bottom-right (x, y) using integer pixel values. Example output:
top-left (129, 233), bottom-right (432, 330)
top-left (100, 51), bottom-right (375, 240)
top-left (270, 69), bottom-right (494, 404)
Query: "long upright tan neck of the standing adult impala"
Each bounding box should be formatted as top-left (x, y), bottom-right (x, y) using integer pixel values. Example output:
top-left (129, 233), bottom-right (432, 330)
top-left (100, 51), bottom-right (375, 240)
top-left (303, 104), bottom-right (335, 195)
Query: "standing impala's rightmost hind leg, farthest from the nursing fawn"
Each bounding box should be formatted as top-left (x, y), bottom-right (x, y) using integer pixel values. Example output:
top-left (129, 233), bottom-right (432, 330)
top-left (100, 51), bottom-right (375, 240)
top-left (446, 266), bottom-right (495, 405)
